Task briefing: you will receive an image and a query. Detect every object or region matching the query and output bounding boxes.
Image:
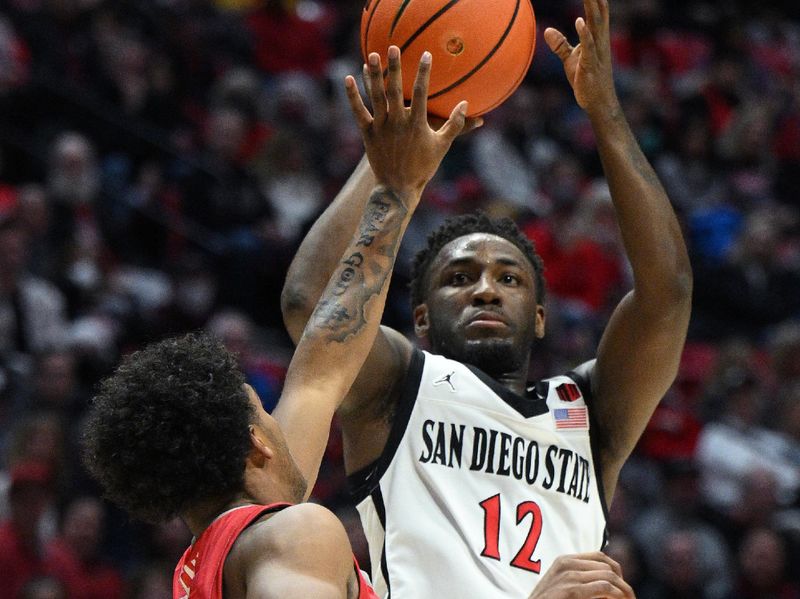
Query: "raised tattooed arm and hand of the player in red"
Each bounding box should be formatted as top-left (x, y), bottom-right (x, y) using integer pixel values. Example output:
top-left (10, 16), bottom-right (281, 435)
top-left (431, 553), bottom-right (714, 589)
top-left (274, 46), bottom-right (466, 492)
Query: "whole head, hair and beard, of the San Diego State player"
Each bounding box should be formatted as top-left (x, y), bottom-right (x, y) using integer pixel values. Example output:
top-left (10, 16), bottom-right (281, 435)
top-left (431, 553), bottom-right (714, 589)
top-left (411, 212), bottom-right (545, 375)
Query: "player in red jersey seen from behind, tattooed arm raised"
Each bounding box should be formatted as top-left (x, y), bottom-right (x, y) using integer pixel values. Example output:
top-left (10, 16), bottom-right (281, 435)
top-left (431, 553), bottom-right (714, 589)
top-left (84, 54), bottom-right (466, 599)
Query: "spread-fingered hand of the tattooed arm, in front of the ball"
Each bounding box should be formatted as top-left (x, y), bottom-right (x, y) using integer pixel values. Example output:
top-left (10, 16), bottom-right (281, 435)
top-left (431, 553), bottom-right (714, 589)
top-left (345, 46), bottom-right (467, 195)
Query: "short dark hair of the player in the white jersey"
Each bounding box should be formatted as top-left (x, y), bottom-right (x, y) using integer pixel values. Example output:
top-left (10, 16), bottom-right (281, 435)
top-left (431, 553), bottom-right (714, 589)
top-left (410, 210), bottom-right (545, 308)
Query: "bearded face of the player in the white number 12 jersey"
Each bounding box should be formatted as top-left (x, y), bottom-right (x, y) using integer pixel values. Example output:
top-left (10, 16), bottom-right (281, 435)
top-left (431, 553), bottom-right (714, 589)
top-left (414, 233), bottom-right (544, 376)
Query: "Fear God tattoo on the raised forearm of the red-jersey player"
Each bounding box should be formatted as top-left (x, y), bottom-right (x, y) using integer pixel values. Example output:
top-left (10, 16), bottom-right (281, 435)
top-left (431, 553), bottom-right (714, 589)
top-left (305, 187), bottom-right (408, 343)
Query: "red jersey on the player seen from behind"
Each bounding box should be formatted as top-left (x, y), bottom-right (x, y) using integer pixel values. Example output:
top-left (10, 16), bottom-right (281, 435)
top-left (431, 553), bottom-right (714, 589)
top-left (172, 503), bottom-right (378, 599)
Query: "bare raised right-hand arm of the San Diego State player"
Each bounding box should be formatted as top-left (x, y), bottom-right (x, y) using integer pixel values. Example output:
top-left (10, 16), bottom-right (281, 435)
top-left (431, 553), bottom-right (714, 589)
top-left (544, 0), bottom-right (692, 500)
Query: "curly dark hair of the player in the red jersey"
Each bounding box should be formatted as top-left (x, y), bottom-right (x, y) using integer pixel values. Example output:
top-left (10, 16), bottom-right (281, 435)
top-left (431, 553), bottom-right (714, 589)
top-left (82, 333), bottom-right (255, 522)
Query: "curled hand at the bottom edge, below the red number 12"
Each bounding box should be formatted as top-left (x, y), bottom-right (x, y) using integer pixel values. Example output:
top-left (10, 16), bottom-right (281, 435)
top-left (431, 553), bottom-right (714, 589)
top-left (528, 551), bottom-right (636, 599)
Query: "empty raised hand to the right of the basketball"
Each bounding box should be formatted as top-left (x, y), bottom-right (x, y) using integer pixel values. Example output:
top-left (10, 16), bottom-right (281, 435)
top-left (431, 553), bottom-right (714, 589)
top-left (544, 0), bottom-right (618, 116)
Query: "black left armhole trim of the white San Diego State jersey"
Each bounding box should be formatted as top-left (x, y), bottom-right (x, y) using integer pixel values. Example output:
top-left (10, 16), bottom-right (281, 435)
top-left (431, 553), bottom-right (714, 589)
top-left (347, 348), bottom-right (425, 505)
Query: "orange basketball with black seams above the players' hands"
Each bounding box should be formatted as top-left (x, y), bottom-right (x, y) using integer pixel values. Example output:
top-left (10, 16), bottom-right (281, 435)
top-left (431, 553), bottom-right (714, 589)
top-left (361, 0), bottom-right (536, 117)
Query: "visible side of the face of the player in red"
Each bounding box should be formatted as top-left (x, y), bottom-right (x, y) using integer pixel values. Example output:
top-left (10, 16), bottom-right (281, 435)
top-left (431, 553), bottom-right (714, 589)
top-left (245, 385), bottom-right (306, 503)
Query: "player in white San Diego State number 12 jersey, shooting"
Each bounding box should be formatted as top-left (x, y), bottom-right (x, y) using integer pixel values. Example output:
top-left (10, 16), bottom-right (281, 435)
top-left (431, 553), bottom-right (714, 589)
top-left (283, 0), bottom-right (692, 599)
